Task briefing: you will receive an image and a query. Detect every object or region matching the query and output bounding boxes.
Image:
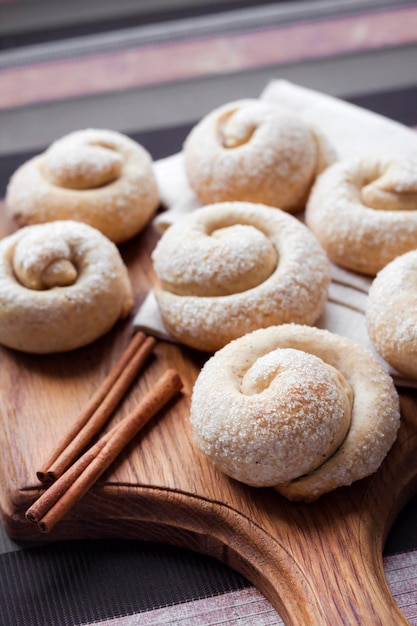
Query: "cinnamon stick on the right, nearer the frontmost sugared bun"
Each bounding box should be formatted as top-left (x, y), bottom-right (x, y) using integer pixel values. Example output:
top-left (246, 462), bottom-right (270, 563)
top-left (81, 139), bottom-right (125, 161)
top-left (26, 369), bottom-right (182, 533)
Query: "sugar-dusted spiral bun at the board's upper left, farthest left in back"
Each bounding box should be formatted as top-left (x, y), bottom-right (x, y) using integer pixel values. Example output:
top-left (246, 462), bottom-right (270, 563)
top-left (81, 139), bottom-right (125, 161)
top-left (6, 129), bottom-right (159, 243)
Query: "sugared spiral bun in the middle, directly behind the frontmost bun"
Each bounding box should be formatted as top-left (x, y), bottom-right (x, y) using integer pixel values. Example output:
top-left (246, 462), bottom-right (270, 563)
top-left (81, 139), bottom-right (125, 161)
top-left (153, 202), bottom-right (330, 352)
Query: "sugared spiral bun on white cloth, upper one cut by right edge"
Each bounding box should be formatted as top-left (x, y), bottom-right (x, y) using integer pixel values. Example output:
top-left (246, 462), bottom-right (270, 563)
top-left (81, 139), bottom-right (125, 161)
top-left (305, 156), bottom-right (417, 276)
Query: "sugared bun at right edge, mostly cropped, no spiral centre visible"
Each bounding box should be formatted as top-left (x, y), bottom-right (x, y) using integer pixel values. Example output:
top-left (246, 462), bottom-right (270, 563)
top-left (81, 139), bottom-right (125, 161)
top-left (366, 250), bottom-right (417, 380)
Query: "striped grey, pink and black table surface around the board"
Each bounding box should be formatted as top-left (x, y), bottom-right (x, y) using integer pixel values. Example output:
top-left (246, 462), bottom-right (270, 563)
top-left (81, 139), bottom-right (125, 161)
top-left (0, 0), bottom-right (417, 626)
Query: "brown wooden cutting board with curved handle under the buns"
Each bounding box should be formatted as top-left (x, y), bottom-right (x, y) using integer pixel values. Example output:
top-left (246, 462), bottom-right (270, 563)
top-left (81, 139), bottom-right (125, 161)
top-left (0, 207), bottom-right (417, 626)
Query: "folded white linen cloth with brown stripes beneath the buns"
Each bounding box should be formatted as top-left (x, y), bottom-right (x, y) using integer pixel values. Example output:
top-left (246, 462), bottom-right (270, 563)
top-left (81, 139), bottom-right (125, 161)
top-left (134, 80), bottom-right (417, 387)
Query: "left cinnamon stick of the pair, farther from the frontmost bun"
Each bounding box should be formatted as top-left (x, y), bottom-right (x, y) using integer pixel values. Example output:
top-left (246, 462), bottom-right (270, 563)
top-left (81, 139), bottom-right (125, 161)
top-left (36, 332), bottom-right (156, 482)
